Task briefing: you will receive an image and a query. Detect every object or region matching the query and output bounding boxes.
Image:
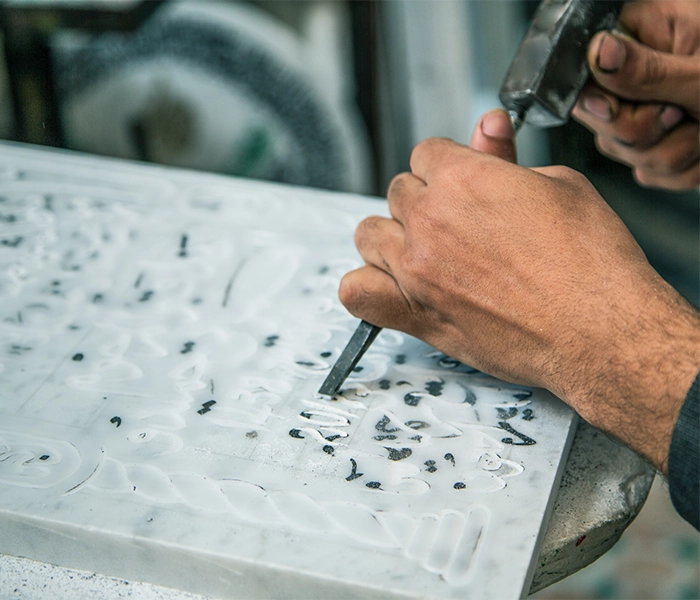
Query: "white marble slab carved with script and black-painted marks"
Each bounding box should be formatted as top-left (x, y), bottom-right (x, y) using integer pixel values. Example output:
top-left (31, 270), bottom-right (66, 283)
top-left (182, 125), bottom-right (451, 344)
top-left (0, 144), bottom-right (573, 598)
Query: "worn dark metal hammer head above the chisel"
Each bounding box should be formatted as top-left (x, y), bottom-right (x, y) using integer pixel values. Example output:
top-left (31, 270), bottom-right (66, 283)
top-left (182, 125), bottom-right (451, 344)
top-left (499, 0), bottom-right (623, 127)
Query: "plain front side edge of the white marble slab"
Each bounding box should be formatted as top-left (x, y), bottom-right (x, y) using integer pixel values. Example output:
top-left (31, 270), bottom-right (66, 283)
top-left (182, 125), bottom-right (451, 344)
top-left (0, 511), bottom-right (416, 600)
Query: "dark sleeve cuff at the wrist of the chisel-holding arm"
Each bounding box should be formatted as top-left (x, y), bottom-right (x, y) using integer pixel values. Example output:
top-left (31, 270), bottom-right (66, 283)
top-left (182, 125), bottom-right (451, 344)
top-left (668, 373), bottom-right (700, 530)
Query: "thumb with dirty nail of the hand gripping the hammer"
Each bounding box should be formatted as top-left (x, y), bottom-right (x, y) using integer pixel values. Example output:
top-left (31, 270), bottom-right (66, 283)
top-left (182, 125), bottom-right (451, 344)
top-left (588, 31), bottom-right (700, 118)
